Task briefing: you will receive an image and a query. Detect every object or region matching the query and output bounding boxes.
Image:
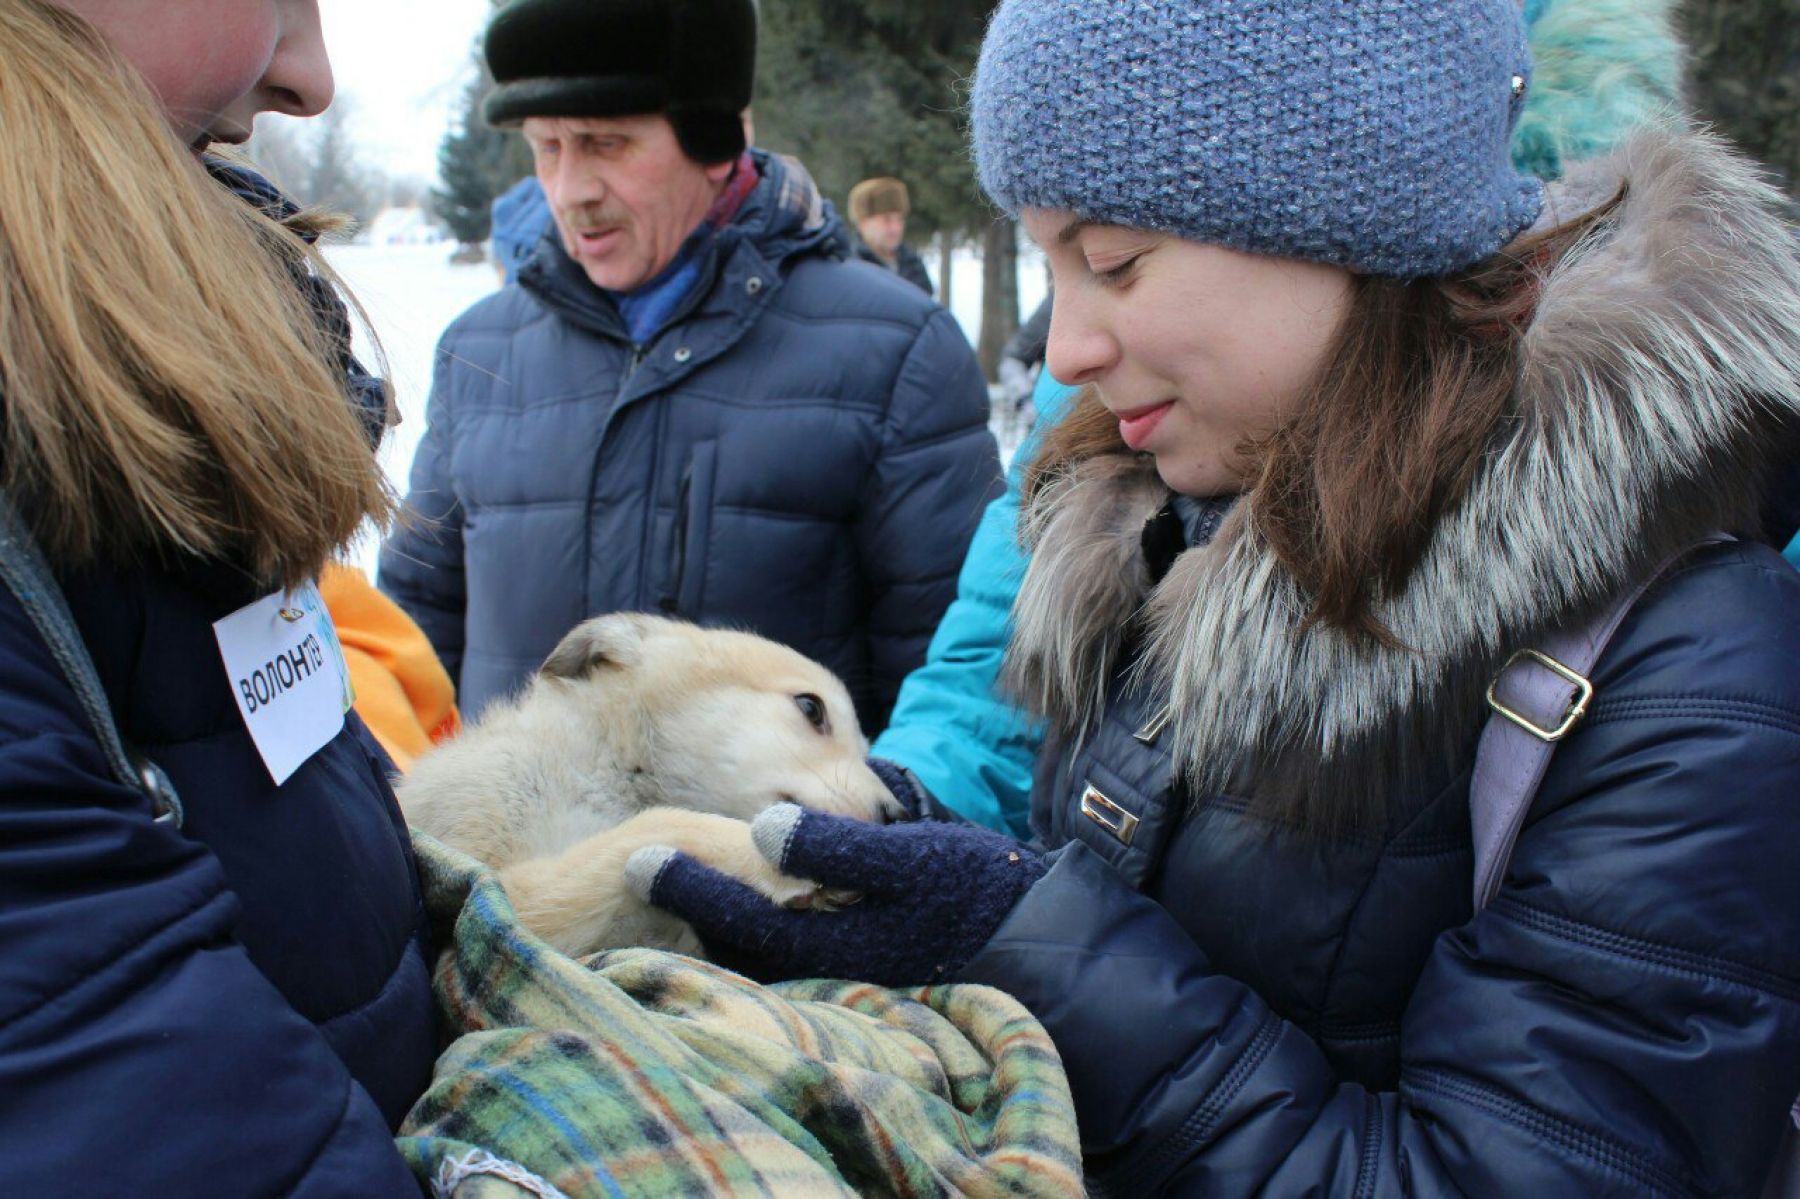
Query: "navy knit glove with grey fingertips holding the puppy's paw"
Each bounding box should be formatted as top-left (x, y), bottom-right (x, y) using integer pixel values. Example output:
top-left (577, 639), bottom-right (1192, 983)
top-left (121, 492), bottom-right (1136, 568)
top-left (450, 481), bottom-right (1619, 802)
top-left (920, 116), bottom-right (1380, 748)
top-left (626, 803), bottom-right (1048, 987)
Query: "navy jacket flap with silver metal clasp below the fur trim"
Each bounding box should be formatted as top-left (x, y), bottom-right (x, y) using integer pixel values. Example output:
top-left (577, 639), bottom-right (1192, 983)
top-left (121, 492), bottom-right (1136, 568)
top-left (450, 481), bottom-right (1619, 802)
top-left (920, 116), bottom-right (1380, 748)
top-left (1048, 676), bottom-right (1181, 888)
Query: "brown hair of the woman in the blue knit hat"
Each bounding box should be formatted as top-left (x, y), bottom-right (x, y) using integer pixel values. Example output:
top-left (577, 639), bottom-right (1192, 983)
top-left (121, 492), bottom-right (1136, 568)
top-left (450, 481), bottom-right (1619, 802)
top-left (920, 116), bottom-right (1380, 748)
top-left (1024, 193), bottom-right (1624, 645)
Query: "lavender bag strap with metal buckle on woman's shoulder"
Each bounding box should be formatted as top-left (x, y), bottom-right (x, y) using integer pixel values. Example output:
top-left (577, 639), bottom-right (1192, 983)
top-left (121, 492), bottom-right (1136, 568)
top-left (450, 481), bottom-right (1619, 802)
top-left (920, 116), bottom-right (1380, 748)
top-left (1469, 533), bottom-right (1733, 911)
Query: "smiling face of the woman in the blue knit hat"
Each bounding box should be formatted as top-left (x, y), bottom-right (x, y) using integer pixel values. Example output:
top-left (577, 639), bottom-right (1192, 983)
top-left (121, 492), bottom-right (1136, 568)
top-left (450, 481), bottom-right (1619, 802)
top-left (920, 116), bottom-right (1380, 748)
top-left (1022, 209), bottom-right (1352, 495)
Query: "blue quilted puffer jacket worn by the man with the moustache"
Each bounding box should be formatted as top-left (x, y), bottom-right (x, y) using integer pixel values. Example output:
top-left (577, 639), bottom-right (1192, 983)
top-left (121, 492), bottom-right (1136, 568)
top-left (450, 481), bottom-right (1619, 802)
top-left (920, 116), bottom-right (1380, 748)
top-left (380, 151), bottom-right (999, 733)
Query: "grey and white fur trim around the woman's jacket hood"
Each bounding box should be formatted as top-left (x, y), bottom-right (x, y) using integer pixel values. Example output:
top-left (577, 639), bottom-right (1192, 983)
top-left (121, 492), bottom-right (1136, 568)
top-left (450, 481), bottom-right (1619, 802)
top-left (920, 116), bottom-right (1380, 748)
top-left (1006, 133), bottom-right (1800, 825)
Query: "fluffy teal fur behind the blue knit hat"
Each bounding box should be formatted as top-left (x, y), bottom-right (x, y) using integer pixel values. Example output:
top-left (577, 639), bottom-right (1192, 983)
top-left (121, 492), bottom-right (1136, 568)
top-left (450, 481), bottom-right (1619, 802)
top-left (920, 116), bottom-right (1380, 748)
top-left (1512, 0), bottom-right (1685, 180)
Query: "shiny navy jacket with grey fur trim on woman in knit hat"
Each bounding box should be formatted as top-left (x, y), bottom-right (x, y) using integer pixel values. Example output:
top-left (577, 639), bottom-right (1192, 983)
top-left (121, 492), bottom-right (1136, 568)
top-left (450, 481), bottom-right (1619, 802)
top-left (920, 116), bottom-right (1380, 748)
top-left (959, 140), bottom-right (1800, 1199)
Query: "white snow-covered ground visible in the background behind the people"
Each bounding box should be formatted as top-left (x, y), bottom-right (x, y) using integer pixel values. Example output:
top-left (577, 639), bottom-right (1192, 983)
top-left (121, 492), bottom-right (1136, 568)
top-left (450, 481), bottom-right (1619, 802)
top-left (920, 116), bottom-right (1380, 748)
top-left (326, 243), bottom-right (1044, 576)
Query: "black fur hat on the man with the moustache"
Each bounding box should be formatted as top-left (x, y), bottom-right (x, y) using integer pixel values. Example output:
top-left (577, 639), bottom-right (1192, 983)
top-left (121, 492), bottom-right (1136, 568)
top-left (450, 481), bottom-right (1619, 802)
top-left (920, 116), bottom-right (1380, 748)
top-left (484, 0), bottom-right (756, 162)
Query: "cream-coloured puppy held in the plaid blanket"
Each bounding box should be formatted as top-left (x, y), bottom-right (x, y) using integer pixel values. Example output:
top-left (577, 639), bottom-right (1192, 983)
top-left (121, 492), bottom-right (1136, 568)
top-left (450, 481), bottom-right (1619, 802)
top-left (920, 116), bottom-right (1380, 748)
top-left (396, 612), bottom-right (902, 956)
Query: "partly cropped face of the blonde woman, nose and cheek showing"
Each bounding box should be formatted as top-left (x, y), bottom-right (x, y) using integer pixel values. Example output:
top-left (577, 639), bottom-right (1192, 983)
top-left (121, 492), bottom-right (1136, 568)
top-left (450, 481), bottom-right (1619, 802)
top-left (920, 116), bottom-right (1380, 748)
top-left (52, 0), bottom-right (331, 153)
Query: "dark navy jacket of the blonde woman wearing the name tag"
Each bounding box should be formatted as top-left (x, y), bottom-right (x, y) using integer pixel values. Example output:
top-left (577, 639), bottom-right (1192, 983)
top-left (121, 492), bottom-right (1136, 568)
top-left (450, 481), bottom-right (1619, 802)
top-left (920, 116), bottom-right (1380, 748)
top-left (0, 163), bottom-right (436, 1197)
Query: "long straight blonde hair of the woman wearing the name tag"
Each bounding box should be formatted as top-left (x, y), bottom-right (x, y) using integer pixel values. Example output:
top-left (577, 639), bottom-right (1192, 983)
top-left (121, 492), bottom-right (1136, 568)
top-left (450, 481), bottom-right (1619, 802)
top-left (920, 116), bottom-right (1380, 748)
top-left (0, 0), bottom-right (392, 585)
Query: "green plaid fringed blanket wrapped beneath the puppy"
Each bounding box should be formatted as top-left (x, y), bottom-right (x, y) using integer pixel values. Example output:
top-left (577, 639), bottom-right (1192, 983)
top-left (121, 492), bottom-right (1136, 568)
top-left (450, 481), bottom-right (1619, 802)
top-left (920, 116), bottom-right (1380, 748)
top-left (400, 835), bottom-right (1082, 1199)
